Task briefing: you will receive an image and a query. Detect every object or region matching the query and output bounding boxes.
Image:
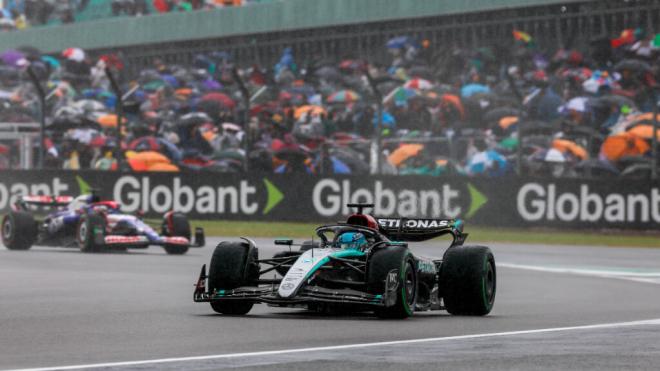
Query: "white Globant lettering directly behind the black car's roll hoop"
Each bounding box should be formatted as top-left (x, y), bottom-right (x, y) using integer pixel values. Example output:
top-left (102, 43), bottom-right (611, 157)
top-left (312, 179), bottom-right (463, 219)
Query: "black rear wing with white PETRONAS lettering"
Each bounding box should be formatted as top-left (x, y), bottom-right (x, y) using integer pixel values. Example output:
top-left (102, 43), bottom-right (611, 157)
top-left (376, 217), bottom-right (467, 245)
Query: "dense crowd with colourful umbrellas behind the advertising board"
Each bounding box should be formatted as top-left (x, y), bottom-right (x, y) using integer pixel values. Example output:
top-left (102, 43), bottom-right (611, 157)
top-left (0, 29), bottom-right (660, 177)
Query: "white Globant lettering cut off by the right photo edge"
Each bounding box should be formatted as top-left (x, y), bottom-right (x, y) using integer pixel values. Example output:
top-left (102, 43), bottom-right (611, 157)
top-left (516, 183), bottom-right (660, 223)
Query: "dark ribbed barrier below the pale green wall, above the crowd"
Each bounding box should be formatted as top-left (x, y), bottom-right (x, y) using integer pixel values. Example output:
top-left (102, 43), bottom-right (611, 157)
top-left (99, 0), bottom-right (660, 75)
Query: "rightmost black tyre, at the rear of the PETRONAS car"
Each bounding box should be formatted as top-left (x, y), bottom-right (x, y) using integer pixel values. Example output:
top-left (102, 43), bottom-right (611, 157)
top-left (440, 246), bottom-right (497, 316)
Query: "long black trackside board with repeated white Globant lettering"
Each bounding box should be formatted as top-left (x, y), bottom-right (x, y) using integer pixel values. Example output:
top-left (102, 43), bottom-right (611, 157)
top-left (0, 171), bottom-right (660, 230)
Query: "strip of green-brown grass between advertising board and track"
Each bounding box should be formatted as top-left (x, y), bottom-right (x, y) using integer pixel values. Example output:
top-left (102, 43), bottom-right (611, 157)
top-left (192, 220), bottom-right (660, 248)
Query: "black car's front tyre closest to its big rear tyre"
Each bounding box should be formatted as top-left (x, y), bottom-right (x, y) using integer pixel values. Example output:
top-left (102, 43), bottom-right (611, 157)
top-left (367, 247), bottom-right (418, 318)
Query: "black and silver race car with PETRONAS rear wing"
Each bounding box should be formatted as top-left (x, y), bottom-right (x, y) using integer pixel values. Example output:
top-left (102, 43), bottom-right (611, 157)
top-left (194, 204), bottom-right (497, 318)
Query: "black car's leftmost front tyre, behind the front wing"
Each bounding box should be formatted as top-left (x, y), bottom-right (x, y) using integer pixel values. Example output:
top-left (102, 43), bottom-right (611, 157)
top-left (208, 242), bottom-right (259, 315)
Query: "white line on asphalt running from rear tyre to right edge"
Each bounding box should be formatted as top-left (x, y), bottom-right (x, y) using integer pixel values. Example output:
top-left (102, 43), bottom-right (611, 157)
top-left (497, 263), bottom-right (660, 285)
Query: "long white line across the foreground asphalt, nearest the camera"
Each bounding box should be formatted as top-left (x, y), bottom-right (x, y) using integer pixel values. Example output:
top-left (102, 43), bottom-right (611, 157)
top-left (13, 318), bottom-right (660, 371)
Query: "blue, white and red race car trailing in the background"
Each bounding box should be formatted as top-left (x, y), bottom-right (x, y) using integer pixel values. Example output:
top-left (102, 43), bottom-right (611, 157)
top-left (2, 194), bottom-right (204, 255)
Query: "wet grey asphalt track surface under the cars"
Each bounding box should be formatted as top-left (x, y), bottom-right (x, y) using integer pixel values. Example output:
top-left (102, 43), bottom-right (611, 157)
top-left (0, 238), bottom-right (660, 370)
